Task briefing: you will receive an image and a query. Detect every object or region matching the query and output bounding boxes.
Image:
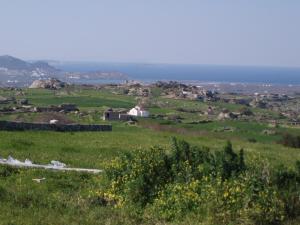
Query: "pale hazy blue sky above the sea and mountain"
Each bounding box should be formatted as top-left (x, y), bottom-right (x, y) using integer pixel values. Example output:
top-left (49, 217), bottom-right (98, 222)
top-left (0, 0), bottom-right (300, 66)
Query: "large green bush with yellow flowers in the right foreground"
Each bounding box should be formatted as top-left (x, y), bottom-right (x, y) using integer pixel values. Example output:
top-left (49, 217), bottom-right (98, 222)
top-left (96, 138), bottom-right (300, 224)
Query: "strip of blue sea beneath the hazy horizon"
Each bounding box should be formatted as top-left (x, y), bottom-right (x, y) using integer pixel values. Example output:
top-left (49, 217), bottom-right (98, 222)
top-left (55, 62), bottom-right (300, 85)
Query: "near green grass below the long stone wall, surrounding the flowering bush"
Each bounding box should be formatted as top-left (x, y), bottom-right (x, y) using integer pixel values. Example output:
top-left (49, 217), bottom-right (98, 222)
top-left (0, 124), bottom-right (300, 224)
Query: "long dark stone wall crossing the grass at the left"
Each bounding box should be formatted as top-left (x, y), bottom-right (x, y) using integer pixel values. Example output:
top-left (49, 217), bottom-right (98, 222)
top-left (0, 121), bottom-right (112, 132)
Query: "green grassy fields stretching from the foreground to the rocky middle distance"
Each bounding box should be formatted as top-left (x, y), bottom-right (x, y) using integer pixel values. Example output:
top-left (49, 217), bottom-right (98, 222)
top-left (0, 88), bottom-right (300, 225)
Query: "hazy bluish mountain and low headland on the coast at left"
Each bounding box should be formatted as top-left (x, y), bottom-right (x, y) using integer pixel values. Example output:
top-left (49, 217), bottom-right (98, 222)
top-left (0, 55), bottom-right (128, 87)
